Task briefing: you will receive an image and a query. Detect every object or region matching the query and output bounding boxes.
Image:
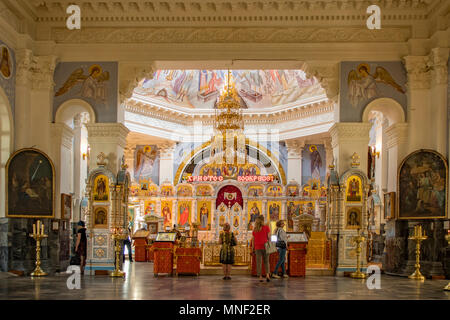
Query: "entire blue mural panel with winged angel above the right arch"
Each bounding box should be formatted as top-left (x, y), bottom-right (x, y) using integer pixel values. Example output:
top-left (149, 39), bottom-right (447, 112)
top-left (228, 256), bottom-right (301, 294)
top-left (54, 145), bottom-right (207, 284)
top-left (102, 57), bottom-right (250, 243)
top-left (340, 61), bottom-right (406, 122)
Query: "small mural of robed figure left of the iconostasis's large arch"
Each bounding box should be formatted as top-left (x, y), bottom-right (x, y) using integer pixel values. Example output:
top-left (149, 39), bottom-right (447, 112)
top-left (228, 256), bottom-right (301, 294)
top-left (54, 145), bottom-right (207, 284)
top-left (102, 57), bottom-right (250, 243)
top-left (134, 145), bottom-right (159, 184)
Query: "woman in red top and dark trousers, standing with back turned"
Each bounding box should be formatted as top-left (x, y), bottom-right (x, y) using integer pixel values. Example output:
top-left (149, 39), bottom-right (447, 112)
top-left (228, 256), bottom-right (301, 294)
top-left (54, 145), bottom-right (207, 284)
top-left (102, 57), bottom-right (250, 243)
top-left (252, 215), bottom-right (270, 282)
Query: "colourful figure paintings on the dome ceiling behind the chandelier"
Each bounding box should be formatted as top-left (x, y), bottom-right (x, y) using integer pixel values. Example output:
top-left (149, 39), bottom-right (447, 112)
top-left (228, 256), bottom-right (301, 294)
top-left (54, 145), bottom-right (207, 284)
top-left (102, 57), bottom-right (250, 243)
top-left (134, 70), bottom-right (325, 109)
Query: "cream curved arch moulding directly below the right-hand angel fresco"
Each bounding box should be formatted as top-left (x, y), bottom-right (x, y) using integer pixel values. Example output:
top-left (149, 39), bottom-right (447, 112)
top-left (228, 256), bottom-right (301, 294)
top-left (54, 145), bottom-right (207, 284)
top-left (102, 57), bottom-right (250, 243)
top-left (362, 98), bottom-right (405, 126)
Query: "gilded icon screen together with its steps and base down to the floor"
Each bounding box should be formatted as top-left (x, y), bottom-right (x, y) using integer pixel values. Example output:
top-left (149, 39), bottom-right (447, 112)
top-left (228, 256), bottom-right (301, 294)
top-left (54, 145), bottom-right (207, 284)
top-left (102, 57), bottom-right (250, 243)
top-left (129, 180), bottom-right (331, 274)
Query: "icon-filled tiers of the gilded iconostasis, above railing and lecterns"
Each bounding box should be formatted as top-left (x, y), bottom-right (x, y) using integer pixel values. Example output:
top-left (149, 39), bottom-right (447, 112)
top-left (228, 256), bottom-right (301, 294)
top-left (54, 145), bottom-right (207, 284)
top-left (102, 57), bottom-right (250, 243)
top-left (130, 179), bottom-right (326, 242)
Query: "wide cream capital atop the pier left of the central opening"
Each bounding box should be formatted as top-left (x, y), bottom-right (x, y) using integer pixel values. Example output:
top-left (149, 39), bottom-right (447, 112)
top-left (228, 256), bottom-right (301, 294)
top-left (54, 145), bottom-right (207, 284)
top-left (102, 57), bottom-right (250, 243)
top-left (86, 123), bottom-right (130, 148)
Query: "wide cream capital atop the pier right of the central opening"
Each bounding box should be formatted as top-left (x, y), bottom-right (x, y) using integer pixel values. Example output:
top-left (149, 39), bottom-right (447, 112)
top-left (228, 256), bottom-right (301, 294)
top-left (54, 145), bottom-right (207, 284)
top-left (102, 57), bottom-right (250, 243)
top-left (329, 122), bottom-right (372, 148)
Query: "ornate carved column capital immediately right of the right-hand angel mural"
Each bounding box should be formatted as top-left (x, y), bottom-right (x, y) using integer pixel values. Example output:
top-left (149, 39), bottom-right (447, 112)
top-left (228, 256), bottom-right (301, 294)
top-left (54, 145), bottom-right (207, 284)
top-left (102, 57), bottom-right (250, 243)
top-left (403, 56), bottom-right (431, 89)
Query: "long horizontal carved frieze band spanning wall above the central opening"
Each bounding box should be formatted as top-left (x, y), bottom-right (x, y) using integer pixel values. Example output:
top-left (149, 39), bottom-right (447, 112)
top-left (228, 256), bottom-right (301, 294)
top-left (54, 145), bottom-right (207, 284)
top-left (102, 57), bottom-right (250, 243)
top-left (50, 26), bottom-right (411, 44)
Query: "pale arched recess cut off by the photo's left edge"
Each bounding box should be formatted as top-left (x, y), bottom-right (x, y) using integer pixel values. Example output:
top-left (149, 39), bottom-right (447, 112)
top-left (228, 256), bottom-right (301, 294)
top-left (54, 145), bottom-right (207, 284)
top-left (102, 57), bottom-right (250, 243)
top-left (0, 87), bottom-right (14, 218)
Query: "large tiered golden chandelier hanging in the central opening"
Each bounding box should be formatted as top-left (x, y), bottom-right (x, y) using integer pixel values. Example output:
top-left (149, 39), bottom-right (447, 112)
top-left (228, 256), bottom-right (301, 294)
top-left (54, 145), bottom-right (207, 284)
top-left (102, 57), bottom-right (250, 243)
top-left (210, 70), bottom-right (247, 165)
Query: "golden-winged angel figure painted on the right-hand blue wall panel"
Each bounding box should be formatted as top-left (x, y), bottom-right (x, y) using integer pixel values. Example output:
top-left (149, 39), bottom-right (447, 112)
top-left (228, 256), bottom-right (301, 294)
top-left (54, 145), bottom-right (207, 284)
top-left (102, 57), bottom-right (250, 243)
top-left (347, 63), bottom-right (405, 107)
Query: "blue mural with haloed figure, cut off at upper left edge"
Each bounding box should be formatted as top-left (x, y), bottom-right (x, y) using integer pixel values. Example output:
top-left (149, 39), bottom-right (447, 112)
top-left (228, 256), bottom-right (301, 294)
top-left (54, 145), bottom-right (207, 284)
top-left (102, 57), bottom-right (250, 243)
top-left (0, 40), bottom-right (16, 116)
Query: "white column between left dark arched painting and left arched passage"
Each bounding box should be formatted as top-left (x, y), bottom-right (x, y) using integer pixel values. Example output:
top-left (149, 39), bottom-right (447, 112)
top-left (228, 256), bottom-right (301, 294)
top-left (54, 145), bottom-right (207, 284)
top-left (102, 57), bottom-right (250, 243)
top-left (51, 123), bottom-right (74, 218)
